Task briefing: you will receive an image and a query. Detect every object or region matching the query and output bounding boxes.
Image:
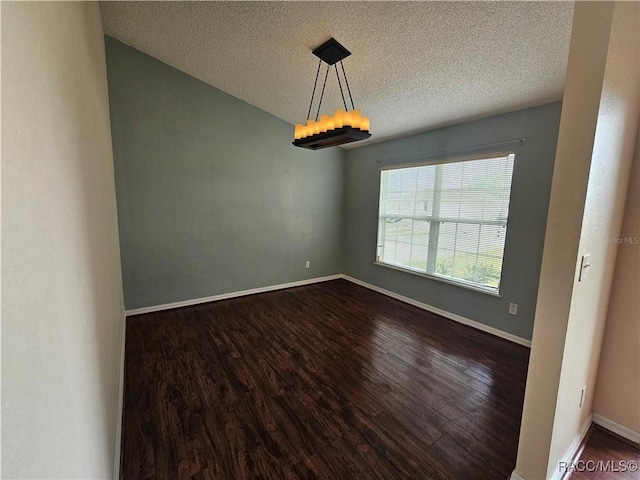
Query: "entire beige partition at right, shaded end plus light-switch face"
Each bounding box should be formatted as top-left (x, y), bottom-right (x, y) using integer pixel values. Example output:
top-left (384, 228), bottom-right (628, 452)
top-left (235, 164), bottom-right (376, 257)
top-left (516, 2), bottom-right (639, 480)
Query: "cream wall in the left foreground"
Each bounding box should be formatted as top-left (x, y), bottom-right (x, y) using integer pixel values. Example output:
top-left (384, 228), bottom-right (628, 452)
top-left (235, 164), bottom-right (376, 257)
top-left (2, 2), bottom-right (124, 479)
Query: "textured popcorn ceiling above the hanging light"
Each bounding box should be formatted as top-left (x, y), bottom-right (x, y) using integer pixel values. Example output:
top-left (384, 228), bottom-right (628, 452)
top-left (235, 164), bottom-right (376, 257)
top-left (101, 2), bottom-right (573, 146)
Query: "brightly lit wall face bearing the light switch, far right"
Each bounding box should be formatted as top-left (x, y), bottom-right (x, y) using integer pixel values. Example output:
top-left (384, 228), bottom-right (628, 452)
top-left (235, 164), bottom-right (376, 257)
top-left (548, 2), bottom-right (640, 476)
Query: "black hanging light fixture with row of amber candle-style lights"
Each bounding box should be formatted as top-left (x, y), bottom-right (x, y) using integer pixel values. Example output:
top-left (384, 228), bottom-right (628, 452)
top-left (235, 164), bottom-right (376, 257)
top-left (293, 38), bottom-right (371, 150)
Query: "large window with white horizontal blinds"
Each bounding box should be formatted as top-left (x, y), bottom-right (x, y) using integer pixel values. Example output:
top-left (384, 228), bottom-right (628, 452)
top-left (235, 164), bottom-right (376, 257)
top-left (377, 153), bottom-right (514, 294)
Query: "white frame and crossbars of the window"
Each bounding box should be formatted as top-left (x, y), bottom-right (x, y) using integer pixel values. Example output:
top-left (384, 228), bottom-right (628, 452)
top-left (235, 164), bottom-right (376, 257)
top-left (374, 150), bottom-right (517, 297)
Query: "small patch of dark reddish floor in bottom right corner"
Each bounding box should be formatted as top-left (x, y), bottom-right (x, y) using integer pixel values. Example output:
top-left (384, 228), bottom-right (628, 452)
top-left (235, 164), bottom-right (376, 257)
top-left (569, 426), bottom-right (640, 480)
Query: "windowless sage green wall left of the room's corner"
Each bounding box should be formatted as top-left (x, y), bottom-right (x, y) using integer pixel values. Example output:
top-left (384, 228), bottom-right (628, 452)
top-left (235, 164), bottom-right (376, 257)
top-left (105, 37), bottom-right (344, 309)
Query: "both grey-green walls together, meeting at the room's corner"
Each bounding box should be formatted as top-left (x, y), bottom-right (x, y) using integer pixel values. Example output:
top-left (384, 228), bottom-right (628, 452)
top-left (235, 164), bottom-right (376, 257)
top-left (105, 37), bottom-right (561, 339)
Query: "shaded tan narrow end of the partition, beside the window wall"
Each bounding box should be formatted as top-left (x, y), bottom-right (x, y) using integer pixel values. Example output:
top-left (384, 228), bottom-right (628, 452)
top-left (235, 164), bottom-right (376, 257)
top-left (516, 2), bottom-right (613, 480)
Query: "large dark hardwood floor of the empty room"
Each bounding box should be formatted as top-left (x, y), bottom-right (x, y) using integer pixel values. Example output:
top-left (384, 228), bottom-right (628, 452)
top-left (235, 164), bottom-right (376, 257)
top-left (121, 280), bottom-right (529, 480)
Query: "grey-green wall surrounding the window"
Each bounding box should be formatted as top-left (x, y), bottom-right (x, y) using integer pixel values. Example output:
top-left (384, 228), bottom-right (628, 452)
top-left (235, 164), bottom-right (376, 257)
top-left (343, 103), bottom-right (561, 339)
